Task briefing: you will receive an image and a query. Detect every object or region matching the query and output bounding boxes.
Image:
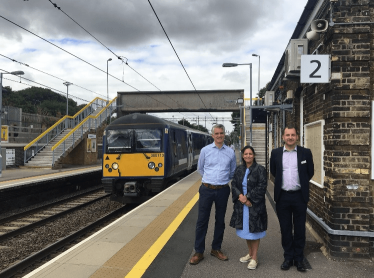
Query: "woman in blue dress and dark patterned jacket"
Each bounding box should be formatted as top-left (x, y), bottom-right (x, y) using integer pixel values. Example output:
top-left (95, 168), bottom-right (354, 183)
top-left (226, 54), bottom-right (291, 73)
top-left (230, 146), bottom-right (268, 269)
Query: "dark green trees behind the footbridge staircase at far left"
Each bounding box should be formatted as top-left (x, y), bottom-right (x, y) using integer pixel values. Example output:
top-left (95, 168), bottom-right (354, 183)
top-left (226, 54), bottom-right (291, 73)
top-left (3, 87), bottom-right (85, 117)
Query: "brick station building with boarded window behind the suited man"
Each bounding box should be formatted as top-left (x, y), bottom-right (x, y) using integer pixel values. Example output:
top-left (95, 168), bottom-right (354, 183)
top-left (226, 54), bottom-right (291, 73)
top-left (267, 0), bottom-right (374, 258)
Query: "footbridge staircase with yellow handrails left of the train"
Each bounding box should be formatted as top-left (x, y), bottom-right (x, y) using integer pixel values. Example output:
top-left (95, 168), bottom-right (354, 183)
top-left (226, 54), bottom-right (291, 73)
top-left (24, 98), bottom-right (116, 168)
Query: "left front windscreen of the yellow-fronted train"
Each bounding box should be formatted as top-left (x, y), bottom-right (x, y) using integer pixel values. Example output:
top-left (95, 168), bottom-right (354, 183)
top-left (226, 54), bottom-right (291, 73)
top-left (106, 129), bottom-right (133, 153)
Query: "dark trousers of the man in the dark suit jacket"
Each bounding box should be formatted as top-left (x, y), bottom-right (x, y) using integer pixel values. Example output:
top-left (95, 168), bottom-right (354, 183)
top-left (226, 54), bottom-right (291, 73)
top-left (276, 190), bottom-right (307, 262)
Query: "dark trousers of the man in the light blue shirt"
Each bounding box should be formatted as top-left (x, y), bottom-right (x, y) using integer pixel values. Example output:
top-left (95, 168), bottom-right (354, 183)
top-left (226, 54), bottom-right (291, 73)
top-left (195, 185), bottom-right (230, 253)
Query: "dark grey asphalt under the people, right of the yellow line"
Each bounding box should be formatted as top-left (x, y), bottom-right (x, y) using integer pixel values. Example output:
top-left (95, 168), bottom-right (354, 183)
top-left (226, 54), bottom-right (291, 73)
top-left (142, 183), bottom-right (374, 278)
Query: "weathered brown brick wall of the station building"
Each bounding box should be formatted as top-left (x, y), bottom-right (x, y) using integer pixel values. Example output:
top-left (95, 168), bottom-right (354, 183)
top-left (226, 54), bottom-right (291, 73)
top-left (270, 0), bottom-right (374, 258)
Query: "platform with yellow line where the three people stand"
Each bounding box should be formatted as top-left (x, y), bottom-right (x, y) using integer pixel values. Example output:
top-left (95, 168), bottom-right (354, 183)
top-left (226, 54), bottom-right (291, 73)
top-left (24, 172), bottom-right (374, 278)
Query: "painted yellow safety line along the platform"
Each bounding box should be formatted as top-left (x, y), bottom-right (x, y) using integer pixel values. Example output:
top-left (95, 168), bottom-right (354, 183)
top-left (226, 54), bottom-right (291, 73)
top-left (125, 193), bottom-right (199, 278)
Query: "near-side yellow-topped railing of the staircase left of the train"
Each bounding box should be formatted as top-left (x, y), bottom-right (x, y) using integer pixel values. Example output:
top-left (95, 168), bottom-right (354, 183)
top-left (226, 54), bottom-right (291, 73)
top-left (51, 98), bottom-right (117, 166)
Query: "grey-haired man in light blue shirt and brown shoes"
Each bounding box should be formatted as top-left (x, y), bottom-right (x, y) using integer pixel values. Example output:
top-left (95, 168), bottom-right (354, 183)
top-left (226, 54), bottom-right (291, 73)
top-left (190, 124), bottom-right (236, 265)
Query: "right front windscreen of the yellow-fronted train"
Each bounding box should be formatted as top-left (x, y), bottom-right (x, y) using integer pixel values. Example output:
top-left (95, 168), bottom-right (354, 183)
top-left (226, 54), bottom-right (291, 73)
top-left (135, 129), bottom-right (161, 152)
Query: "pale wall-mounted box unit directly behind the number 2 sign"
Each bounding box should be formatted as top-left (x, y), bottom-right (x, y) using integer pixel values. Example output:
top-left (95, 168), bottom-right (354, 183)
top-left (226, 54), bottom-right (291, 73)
top-left (285, 39), bottom-right (308, 77)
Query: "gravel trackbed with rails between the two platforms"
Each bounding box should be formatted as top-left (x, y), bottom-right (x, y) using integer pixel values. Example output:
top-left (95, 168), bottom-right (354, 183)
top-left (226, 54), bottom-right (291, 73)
top-left (0, 189), bottom-right (127, 278)
